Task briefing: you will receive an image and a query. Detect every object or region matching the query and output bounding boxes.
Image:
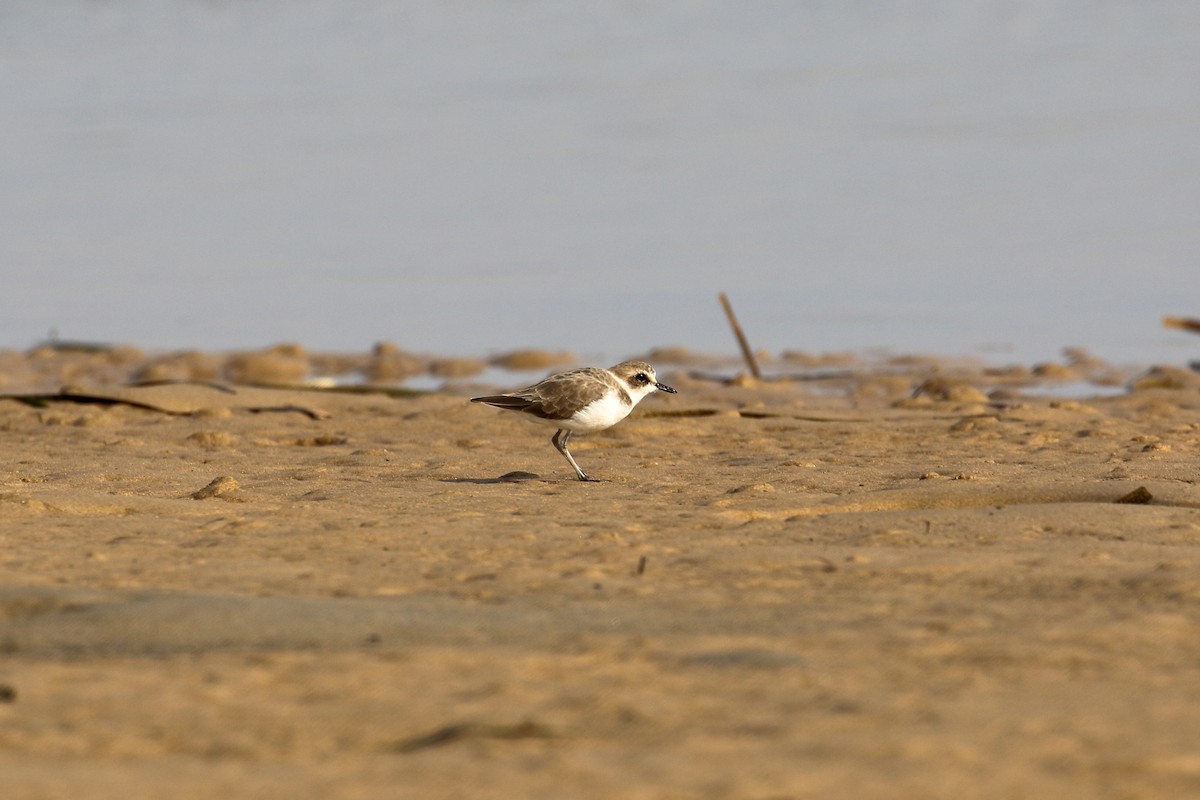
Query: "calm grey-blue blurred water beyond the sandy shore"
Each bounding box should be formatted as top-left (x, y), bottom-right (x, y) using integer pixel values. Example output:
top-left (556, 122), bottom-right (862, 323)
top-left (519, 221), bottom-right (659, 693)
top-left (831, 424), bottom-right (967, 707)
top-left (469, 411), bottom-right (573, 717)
top-left (0, 0), bottom-right (1200, 363)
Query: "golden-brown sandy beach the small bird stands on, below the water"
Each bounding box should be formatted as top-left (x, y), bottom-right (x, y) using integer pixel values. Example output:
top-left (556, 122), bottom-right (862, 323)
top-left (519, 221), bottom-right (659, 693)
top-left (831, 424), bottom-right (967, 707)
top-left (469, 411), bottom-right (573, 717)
top-left (0, 350), bottom-right (1200, 800)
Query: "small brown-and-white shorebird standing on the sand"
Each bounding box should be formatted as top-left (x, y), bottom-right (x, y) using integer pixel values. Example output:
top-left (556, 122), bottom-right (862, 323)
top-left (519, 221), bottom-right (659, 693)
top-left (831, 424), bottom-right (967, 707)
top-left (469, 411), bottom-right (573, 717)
top-left (470, 361), bottom-right (676, 481)
